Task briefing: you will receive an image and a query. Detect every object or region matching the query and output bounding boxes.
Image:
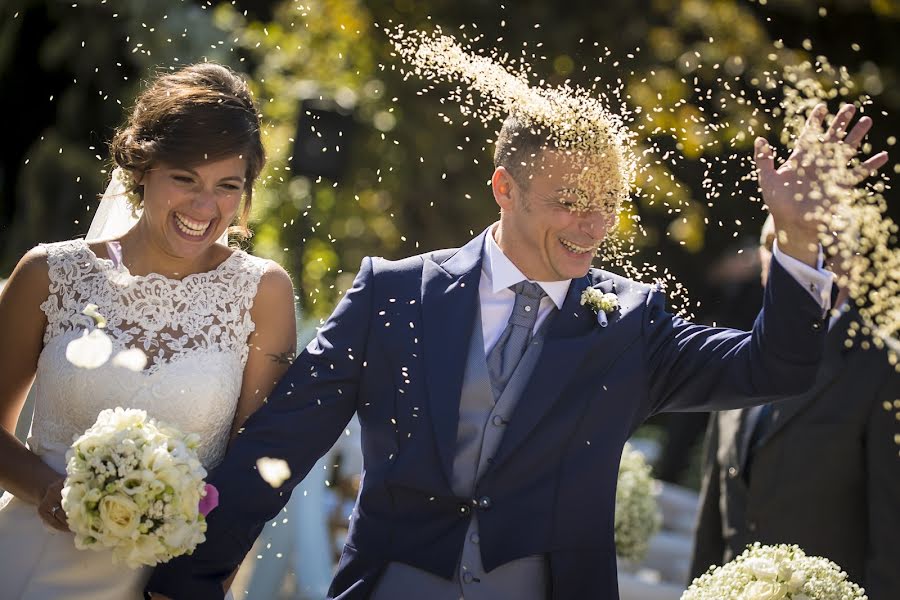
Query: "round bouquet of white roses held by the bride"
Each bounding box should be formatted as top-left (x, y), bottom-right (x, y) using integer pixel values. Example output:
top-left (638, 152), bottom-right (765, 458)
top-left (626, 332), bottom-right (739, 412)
top-left (62, 408), bottom-right (217, 568)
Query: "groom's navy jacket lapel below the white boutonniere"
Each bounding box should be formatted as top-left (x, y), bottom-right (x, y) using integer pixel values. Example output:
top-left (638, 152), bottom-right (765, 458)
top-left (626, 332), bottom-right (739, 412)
top-left (492, 276), bottom-right (618, 468)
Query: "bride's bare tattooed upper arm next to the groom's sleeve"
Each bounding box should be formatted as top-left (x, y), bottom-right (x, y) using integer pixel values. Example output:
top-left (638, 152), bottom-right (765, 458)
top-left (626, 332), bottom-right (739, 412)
top-left (231, 263), bottom-right (297, 439)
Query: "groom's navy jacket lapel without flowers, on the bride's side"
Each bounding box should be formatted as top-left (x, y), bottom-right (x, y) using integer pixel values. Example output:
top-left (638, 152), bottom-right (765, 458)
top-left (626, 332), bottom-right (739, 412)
top-left (422, 232), bottom-right (485, 485)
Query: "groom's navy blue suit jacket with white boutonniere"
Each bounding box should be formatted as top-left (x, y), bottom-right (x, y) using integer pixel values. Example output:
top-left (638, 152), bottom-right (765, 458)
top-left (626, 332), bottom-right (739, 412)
top-left (149, 227), bottom-right (826, 600)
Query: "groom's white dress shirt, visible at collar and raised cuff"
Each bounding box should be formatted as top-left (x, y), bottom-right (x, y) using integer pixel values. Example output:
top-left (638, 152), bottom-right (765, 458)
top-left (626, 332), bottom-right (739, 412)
top-left (478, 229), bottom-right (834, 355)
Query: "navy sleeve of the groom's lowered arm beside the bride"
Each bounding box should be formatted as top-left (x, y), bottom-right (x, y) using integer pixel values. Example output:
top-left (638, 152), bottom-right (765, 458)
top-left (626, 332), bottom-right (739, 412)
top-left (147, 258), bottom-right (373, 600)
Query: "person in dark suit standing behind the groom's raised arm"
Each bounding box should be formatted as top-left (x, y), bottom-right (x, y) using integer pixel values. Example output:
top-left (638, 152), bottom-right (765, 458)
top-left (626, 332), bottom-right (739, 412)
top-left (691, 213), bottom-right (900, 600)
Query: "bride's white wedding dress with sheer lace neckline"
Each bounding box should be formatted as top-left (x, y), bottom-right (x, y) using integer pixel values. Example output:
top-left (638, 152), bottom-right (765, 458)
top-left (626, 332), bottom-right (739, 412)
top-left (0, 240), bottom-right (267, 600)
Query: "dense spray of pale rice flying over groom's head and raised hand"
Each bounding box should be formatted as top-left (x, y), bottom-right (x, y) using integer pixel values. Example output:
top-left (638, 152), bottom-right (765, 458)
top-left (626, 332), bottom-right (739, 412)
top-left (387, 26), bottom-right (900, 360)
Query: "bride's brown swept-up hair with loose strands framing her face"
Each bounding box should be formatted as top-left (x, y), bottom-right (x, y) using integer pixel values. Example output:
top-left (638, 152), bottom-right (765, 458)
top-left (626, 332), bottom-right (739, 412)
top-left (110, 63), bottom-right (266, 237)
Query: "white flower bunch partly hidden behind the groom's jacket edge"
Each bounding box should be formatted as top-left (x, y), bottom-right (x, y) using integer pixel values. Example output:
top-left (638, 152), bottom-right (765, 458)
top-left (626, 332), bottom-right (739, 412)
top-left (615, 444), bottom-right (662, 562)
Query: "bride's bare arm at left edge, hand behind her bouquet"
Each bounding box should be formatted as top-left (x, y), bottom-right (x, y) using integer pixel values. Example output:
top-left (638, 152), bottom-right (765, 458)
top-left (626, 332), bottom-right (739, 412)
top-left (0, 248), bottom-right (64, 528)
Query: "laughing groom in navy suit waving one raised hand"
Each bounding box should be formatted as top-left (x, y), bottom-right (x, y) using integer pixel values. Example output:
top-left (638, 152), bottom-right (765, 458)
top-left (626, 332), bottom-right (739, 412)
top-left (148, 106), bottom-right (883, 600)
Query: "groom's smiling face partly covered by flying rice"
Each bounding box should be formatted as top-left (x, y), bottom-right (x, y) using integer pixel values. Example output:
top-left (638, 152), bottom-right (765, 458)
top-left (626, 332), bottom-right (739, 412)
top-left (491, 150), bottom-right (614, 281)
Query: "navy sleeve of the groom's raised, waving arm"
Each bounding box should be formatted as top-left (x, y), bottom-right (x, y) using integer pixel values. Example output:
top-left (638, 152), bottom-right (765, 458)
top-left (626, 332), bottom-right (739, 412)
top-left (644, 255), bottom-right (828, 414)
